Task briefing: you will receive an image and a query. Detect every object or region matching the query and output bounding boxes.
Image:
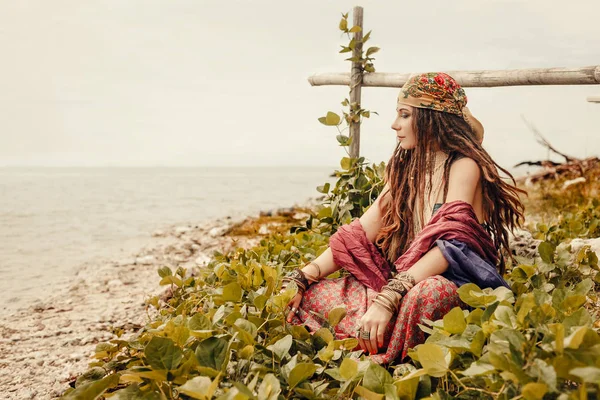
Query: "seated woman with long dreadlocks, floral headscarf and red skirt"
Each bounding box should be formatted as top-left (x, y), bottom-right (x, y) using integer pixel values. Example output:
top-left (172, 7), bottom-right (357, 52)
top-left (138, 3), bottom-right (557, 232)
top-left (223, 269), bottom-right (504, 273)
top-left (284, 73), bottom-right (523, 363)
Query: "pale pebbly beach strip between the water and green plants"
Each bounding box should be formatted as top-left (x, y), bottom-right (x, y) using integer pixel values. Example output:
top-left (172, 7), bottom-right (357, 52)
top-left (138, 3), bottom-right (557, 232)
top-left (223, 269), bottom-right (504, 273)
top-left (0, 203), bottom-right (314, 399)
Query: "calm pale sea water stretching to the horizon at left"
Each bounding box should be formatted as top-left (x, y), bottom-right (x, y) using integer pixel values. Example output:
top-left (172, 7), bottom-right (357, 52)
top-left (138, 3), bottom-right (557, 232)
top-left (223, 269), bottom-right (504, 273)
top-left (0, 167), bottom-right (333, 314)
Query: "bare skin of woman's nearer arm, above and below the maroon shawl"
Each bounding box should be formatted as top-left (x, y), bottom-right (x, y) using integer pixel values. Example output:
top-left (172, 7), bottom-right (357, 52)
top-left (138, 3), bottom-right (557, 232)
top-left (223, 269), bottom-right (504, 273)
top-left (408, 158), bottom-right (481, 282)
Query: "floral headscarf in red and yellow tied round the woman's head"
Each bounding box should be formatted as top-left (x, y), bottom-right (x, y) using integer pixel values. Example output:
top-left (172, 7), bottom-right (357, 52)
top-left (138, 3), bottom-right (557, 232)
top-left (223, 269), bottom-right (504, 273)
top-left (398, 72), bottom-right (484, 143)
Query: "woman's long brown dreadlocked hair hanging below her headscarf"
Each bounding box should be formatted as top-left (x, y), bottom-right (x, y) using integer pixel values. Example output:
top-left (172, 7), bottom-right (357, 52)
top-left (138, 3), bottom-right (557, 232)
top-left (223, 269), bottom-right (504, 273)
top-left (376, 108), bottom-right (525, 273)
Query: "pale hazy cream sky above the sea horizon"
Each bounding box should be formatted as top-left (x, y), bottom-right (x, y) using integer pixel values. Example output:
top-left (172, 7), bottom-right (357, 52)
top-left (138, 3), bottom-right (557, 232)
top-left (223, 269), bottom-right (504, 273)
top-left (0, 0), bottom-right (600, 167)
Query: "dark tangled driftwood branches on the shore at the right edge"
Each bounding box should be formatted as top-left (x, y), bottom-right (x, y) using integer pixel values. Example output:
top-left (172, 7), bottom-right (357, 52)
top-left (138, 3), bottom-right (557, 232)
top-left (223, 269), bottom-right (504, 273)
top-left (514, 119), bottom-right (600, 183)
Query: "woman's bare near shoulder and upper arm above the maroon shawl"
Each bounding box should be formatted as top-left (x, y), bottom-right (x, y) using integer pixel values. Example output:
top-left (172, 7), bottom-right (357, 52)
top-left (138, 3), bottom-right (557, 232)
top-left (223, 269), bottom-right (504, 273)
top-left (446, 157), bottom-right (481, 205)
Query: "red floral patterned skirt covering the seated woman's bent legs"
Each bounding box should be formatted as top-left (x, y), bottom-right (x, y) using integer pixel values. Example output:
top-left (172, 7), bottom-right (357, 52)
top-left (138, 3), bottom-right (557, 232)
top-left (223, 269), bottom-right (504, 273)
top-left (292, 275), bottom-right (462, 364)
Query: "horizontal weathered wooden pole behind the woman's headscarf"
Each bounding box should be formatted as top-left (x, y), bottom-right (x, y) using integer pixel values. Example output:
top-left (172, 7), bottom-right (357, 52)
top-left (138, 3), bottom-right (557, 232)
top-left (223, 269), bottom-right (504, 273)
top-left (308, 65), bottom-right (600, 88)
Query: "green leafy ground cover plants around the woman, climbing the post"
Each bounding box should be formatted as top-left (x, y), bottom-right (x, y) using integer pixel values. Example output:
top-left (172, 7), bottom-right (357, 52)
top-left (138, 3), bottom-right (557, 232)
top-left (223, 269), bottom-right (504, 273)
top-left (59, 10), bottom-right (600, 400)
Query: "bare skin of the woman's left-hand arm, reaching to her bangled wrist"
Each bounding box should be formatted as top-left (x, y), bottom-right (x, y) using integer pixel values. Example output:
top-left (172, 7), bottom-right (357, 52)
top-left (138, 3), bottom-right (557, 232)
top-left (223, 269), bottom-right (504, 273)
top-left (302, 185), bottom-right (388, 278)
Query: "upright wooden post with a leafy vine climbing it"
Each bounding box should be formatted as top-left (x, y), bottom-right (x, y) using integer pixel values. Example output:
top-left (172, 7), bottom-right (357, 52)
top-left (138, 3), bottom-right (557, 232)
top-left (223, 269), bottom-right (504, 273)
top-left (349, 6), bottom-right (363, 158)
